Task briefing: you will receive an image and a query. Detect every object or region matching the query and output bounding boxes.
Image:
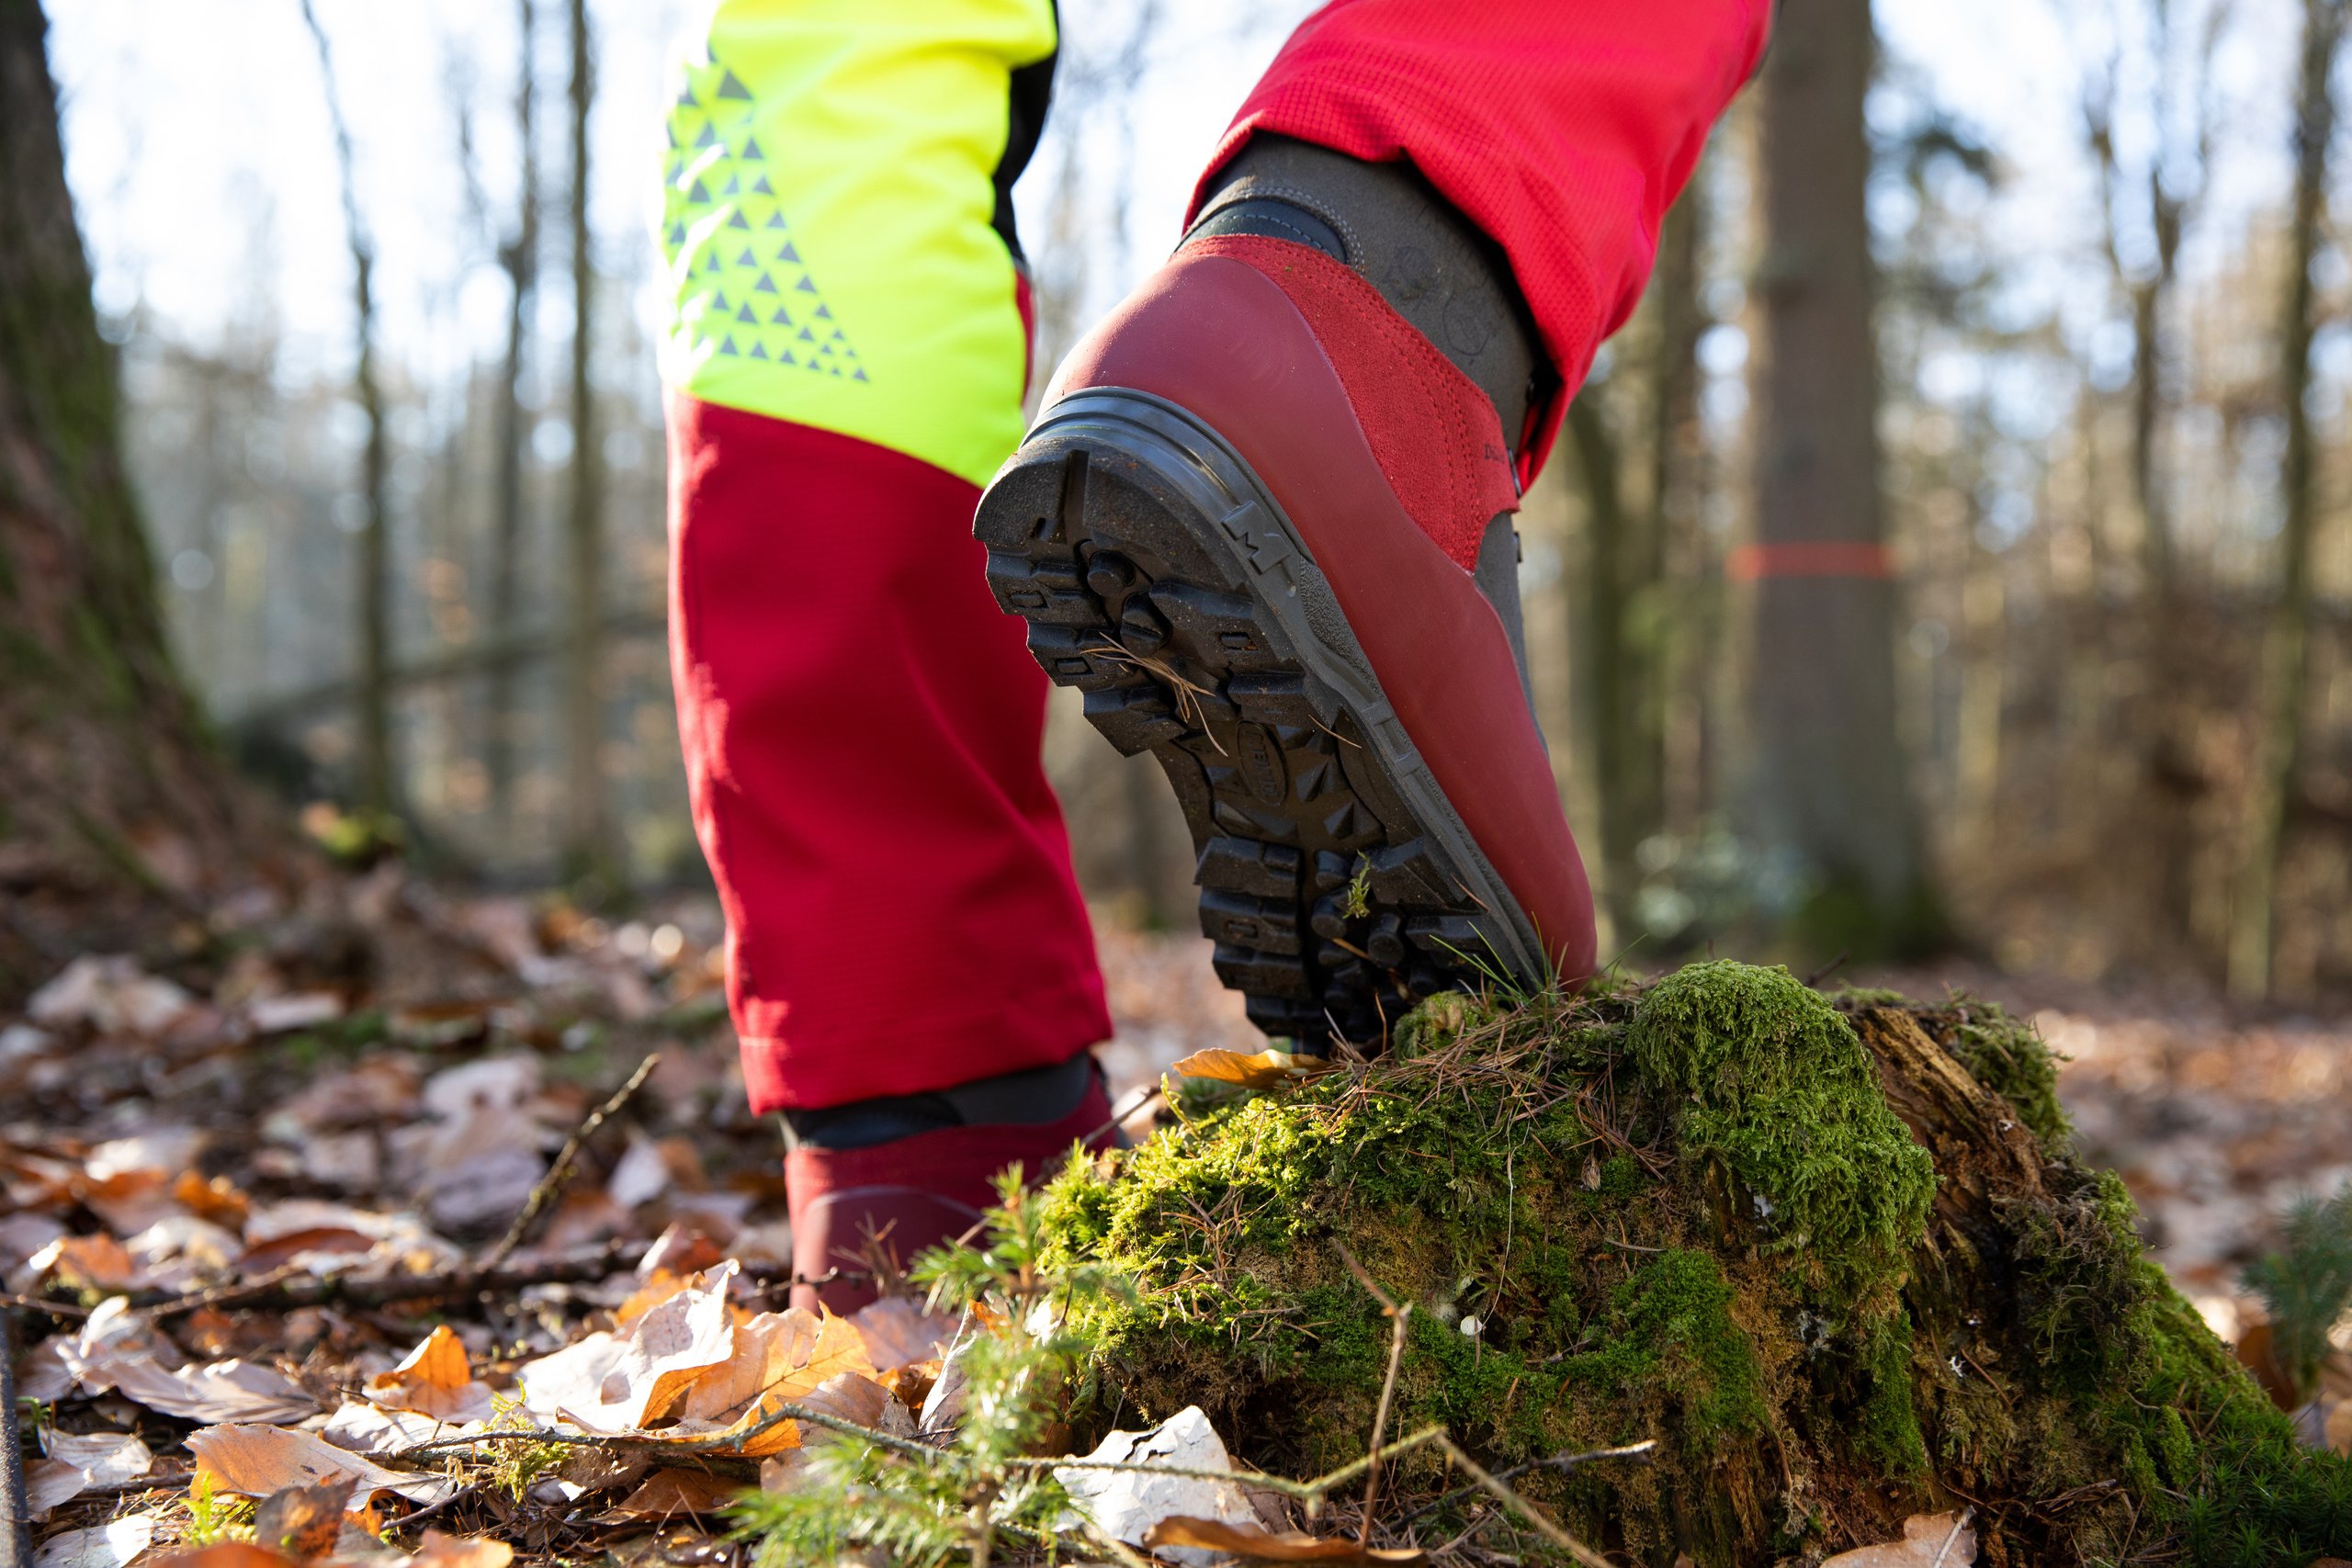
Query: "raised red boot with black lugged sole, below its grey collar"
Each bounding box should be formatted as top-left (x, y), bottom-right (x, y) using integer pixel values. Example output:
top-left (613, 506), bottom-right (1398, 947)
top-left (974, 184), bottom-right (1592, 1051)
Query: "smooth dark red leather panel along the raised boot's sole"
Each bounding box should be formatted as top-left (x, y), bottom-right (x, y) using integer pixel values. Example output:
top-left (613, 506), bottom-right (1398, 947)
top-left (1045, 249), bottom-right (1595, 978)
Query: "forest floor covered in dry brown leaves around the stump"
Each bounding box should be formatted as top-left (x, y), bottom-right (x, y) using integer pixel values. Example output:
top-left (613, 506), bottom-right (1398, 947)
top-left (0, 867), bottom-right (2352, 1568)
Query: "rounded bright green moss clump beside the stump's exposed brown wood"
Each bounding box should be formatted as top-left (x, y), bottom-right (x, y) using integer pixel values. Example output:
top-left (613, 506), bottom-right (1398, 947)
top-left (1628, 962), bottom-right (1936, 1303)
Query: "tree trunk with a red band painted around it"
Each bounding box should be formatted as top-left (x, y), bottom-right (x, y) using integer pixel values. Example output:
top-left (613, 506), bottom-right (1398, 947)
top-left (1736, 0), bottom-right (1940, 957)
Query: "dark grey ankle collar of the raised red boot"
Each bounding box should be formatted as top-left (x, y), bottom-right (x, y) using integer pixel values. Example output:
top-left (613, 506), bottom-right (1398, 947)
top-left (1185, 134), bottom-right (1547, 451)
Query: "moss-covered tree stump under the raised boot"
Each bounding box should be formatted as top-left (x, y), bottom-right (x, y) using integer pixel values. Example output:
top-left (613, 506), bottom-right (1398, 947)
top-left (1045, 964), bottom-right (2352, 1568)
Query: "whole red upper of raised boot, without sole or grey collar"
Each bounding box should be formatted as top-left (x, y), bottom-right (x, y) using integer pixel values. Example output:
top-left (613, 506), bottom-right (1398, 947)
top-left (1045, 235), bottom-right (1595, 980)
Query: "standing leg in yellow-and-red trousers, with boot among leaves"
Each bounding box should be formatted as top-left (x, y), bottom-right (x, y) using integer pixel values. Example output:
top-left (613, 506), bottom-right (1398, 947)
top-left (661, 0), bottom-right (1110, 1303)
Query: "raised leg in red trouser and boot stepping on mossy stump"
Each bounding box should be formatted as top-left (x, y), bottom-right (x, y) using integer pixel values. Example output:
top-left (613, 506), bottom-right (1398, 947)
top-left (976, 0), bottom-right (1767, 1048)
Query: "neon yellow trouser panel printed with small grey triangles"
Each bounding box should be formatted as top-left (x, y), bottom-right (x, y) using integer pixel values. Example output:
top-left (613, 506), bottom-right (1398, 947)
top-left (661, 0), bottom-right (1054, 484)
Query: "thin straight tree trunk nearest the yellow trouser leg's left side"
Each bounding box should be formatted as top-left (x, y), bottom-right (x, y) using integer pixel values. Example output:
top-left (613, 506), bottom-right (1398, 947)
top-left (564, 0), bottom-right (616, 891)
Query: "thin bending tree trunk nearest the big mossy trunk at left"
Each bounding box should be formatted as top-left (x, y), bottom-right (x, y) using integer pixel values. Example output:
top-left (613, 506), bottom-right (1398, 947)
top-left (301, 0), bottom-right (395, 811)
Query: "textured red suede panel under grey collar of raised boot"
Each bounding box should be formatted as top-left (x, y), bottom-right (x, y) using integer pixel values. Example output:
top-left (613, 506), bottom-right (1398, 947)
top-left (1183, 235), bottom-right (1520, 571)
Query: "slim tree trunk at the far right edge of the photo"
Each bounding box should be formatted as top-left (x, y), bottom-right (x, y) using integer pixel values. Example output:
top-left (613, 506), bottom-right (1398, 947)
top-left (2230, 0), bottom-right (2345, 997)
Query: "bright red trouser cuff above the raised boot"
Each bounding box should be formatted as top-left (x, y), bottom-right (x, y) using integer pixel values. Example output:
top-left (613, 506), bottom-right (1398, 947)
top-left (1185, 0), bottom-right (1771, 479)
